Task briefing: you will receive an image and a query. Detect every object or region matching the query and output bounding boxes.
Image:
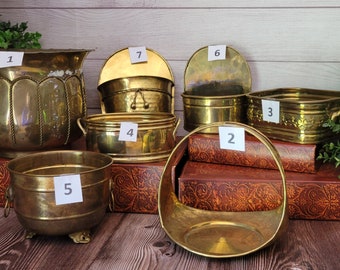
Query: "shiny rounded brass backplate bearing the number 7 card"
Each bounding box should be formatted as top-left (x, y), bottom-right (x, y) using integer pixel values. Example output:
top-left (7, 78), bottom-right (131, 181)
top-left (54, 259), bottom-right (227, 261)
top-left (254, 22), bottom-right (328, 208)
top-left (98, 48), bottom-right (174, 86)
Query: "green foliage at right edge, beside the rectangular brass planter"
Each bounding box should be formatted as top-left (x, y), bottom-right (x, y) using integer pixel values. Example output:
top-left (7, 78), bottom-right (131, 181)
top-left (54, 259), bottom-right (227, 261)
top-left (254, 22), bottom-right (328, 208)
top-left (317, 119), bottom-right (340, 171)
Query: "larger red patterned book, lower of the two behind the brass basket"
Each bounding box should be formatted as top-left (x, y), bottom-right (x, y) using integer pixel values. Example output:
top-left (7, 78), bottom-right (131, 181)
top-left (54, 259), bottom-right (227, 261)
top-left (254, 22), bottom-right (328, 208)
top-left (178, 161), bottom-right (340, 220)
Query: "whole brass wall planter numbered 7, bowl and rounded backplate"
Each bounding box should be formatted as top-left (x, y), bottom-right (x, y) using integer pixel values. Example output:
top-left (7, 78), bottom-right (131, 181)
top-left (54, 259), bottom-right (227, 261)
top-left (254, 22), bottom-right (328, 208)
top-left (98, 48), bottom-right (175, 114)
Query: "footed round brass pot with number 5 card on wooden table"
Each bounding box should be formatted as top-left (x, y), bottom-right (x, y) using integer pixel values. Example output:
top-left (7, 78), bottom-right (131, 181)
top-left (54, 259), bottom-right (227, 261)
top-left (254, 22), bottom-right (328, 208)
top-left (7, 150), bottom-right (113, 243)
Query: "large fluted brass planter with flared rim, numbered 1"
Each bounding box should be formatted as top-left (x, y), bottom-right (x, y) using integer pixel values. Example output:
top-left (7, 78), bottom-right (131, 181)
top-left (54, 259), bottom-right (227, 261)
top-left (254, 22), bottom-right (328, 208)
top-left (0, 50), bottom-right (90, 158)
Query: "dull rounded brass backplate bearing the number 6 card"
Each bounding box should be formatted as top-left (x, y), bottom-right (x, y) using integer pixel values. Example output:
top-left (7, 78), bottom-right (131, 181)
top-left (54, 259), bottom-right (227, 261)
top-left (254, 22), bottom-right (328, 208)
top-left (184, 46), bottom-right (251, 95)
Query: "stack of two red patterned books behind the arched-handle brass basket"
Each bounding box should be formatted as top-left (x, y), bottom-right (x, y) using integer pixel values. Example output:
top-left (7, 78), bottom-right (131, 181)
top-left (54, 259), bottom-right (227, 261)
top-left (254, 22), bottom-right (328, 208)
top-left (178, 134), bottom-right (340, 220)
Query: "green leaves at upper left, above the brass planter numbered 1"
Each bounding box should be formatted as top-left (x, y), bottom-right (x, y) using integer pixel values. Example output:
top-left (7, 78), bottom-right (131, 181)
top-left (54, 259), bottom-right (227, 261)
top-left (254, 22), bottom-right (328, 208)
top-left (0, 22), bottom-right (41, 49)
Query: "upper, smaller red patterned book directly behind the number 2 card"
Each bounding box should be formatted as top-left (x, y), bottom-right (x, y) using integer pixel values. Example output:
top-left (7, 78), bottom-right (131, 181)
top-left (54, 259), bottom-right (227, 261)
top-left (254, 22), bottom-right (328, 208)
top-left (188, 134), bottom-right (321, 173)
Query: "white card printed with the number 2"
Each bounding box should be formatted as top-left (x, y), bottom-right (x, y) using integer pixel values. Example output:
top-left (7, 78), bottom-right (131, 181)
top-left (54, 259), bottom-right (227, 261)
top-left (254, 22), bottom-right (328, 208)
top-left (218, 126), bottom-right (245, 151)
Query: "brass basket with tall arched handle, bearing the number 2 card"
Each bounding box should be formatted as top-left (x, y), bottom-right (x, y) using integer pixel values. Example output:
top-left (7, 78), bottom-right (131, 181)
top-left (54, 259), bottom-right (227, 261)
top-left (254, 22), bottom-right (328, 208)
top-left (158, 122), bottom-right (288, 258)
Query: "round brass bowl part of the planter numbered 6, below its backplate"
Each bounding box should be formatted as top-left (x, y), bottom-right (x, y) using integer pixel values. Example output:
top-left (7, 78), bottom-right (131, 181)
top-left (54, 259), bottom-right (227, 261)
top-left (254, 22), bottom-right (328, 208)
top-left (182, 82), bottom-right (247, 133)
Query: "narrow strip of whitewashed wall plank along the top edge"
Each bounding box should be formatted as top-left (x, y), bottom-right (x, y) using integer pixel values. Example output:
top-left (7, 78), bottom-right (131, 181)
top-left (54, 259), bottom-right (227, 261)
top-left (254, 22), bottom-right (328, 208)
top-left (0, 0), bottom-right (339, 8)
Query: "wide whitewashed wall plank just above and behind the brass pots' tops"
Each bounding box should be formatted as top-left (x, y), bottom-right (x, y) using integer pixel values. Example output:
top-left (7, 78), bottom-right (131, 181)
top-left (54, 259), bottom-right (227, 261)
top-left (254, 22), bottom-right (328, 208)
top-left (0, 8), bottom-right (340, 62)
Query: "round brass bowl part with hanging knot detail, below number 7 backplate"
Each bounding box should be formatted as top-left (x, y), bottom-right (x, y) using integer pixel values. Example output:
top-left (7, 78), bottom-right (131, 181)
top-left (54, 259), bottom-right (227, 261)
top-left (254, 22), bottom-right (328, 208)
top-left (98, 76), bottom-right (174, 113)
